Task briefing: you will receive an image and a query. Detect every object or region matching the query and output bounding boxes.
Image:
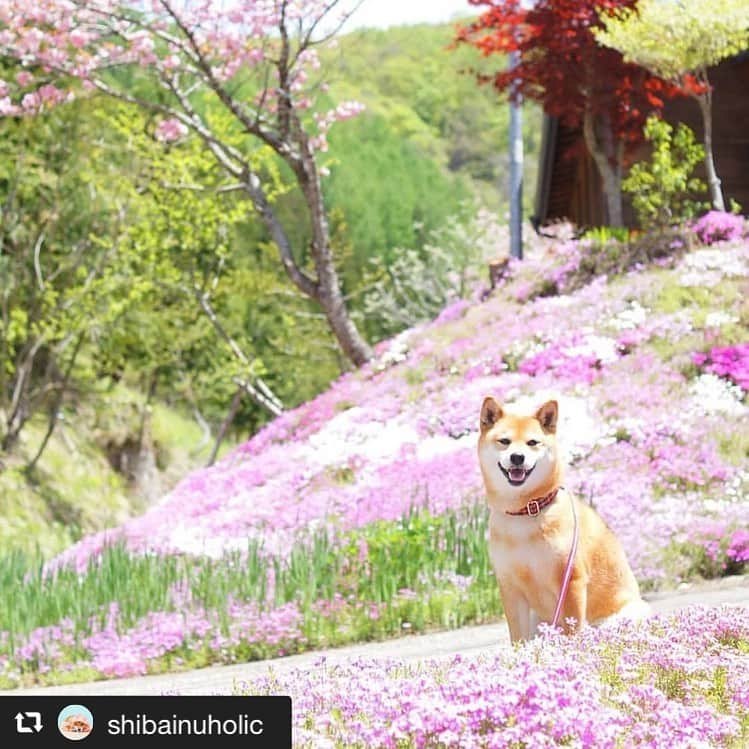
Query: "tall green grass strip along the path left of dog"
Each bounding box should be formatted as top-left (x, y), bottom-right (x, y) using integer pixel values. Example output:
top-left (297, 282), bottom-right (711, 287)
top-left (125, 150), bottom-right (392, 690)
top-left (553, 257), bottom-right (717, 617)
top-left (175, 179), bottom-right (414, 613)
top-left (0, 506), bottom-right (502, 686)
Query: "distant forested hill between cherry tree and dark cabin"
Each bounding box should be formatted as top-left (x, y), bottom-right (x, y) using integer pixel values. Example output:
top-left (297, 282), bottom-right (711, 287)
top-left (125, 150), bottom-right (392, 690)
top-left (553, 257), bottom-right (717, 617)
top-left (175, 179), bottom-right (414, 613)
top-left (306, 24), bottom-right (541, 276)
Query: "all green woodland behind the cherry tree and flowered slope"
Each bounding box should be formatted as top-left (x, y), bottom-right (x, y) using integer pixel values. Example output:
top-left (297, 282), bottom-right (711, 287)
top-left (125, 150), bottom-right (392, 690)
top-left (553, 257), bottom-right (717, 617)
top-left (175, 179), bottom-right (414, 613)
top-left (0, 20), bottom-right (539, 550)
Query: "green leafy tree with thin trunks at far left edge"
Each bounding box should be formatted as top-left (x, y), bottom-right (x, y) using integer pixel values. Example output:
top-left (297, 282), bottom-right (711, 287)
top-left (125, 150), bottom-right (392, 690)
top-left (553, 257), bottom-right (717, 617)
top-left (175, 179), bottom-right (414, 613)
top-left (0, 101), bottom-right (149, 458)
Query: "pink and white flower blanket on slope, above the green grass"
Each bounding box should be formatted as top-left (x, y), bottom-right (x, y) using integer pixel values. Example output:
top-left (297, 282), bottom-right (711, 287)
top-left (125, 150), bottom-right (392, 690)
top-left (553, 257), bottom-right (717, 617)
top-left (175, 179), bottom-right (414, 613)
top-left (60, 216), bottom-right (749, 583)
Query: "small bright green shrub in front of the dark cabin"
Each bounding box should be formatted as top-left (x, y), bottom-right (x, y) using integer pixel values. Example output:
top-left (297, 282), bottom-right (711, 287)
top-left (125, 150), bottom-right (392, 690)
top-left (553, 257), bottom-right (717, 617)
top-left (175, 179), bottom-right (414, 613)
top-left (622, 117), bottom-right (706, 229)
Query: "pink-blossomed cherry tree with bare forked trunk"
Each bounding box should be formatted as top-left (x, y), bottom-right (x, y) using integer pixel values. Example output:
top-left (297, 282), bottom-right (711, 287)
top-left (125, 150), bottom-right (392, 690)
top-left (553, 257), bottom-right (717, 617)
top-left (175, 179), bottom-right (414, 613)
top-left (0, 0), bottom-right (371, 366)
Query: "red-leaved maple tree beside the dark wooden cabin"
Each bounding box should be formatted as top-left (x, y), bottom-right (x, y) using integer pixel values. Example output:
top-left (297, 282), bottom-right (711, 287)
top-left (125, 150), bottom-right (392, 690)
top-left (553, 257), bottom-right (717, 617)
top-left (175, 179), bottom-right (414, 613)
top-left (458, 0), bottom-right (680, 226)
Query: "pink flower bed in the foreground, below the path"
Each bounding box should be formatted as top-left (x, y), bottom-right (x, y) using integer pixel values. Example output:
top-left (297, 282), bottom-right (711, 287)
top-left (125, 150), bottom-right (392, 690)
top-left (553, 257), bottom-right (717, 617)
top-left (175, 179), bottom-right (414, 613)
top-left (245, 607), bottom-right (749, 749)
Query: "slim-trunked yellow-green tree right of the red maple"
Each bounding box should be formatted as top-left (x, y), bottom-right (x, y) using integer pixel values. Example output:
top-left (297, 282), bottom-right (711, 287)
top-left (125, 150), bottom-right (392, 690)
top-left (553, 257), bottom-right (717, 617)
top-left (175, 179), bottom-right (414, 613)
top-left (595, 0), bottom-right (749, 211)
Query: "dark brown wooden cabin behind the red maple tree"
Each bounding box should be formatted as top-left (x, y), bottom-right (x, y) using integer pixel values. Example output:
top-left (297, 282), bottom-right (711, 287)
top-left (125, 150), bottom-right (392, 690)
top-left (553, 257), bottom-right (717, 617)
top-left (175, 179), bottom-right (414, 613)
top-left (534, 52), bottom-right (749, 227)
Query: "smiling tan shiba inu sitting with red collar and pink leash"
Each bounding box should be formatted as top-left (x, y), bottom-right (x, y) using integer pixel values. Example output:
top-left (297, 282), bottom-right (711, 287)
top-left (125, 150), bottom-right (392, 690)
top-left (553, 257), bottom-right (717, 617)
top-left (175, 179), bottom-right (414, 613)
top-left (478, 397), bottom-right (649, 642)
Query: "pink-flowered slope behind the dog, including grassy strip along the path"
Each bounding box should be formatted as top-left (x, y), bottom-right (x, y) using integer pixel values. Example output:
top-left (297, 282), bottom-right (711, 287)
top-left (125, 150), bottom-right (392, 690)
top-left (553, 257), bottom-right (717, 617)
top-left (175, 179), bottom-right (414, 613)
top-left (0, 216), bottom-right (749, 684)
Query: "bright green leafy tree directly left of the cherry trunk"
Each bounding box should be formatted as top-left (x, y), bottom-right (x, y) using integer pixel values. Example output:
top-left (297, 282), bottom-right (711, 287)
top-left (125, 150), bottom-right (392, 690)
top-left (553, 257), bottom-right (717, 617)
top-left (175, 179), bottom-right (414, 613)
top-left (93, 105), bottom-right (345, 444)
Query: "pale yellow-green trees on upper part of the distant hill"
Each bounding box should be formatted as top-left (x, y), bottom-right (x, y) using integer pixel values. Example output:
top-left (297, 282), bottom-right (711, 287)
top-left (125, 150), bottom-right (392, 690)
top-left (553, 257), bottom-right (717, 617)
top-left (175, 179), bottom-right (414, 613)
top-left (323, 24), bottom-right (541, 213)
